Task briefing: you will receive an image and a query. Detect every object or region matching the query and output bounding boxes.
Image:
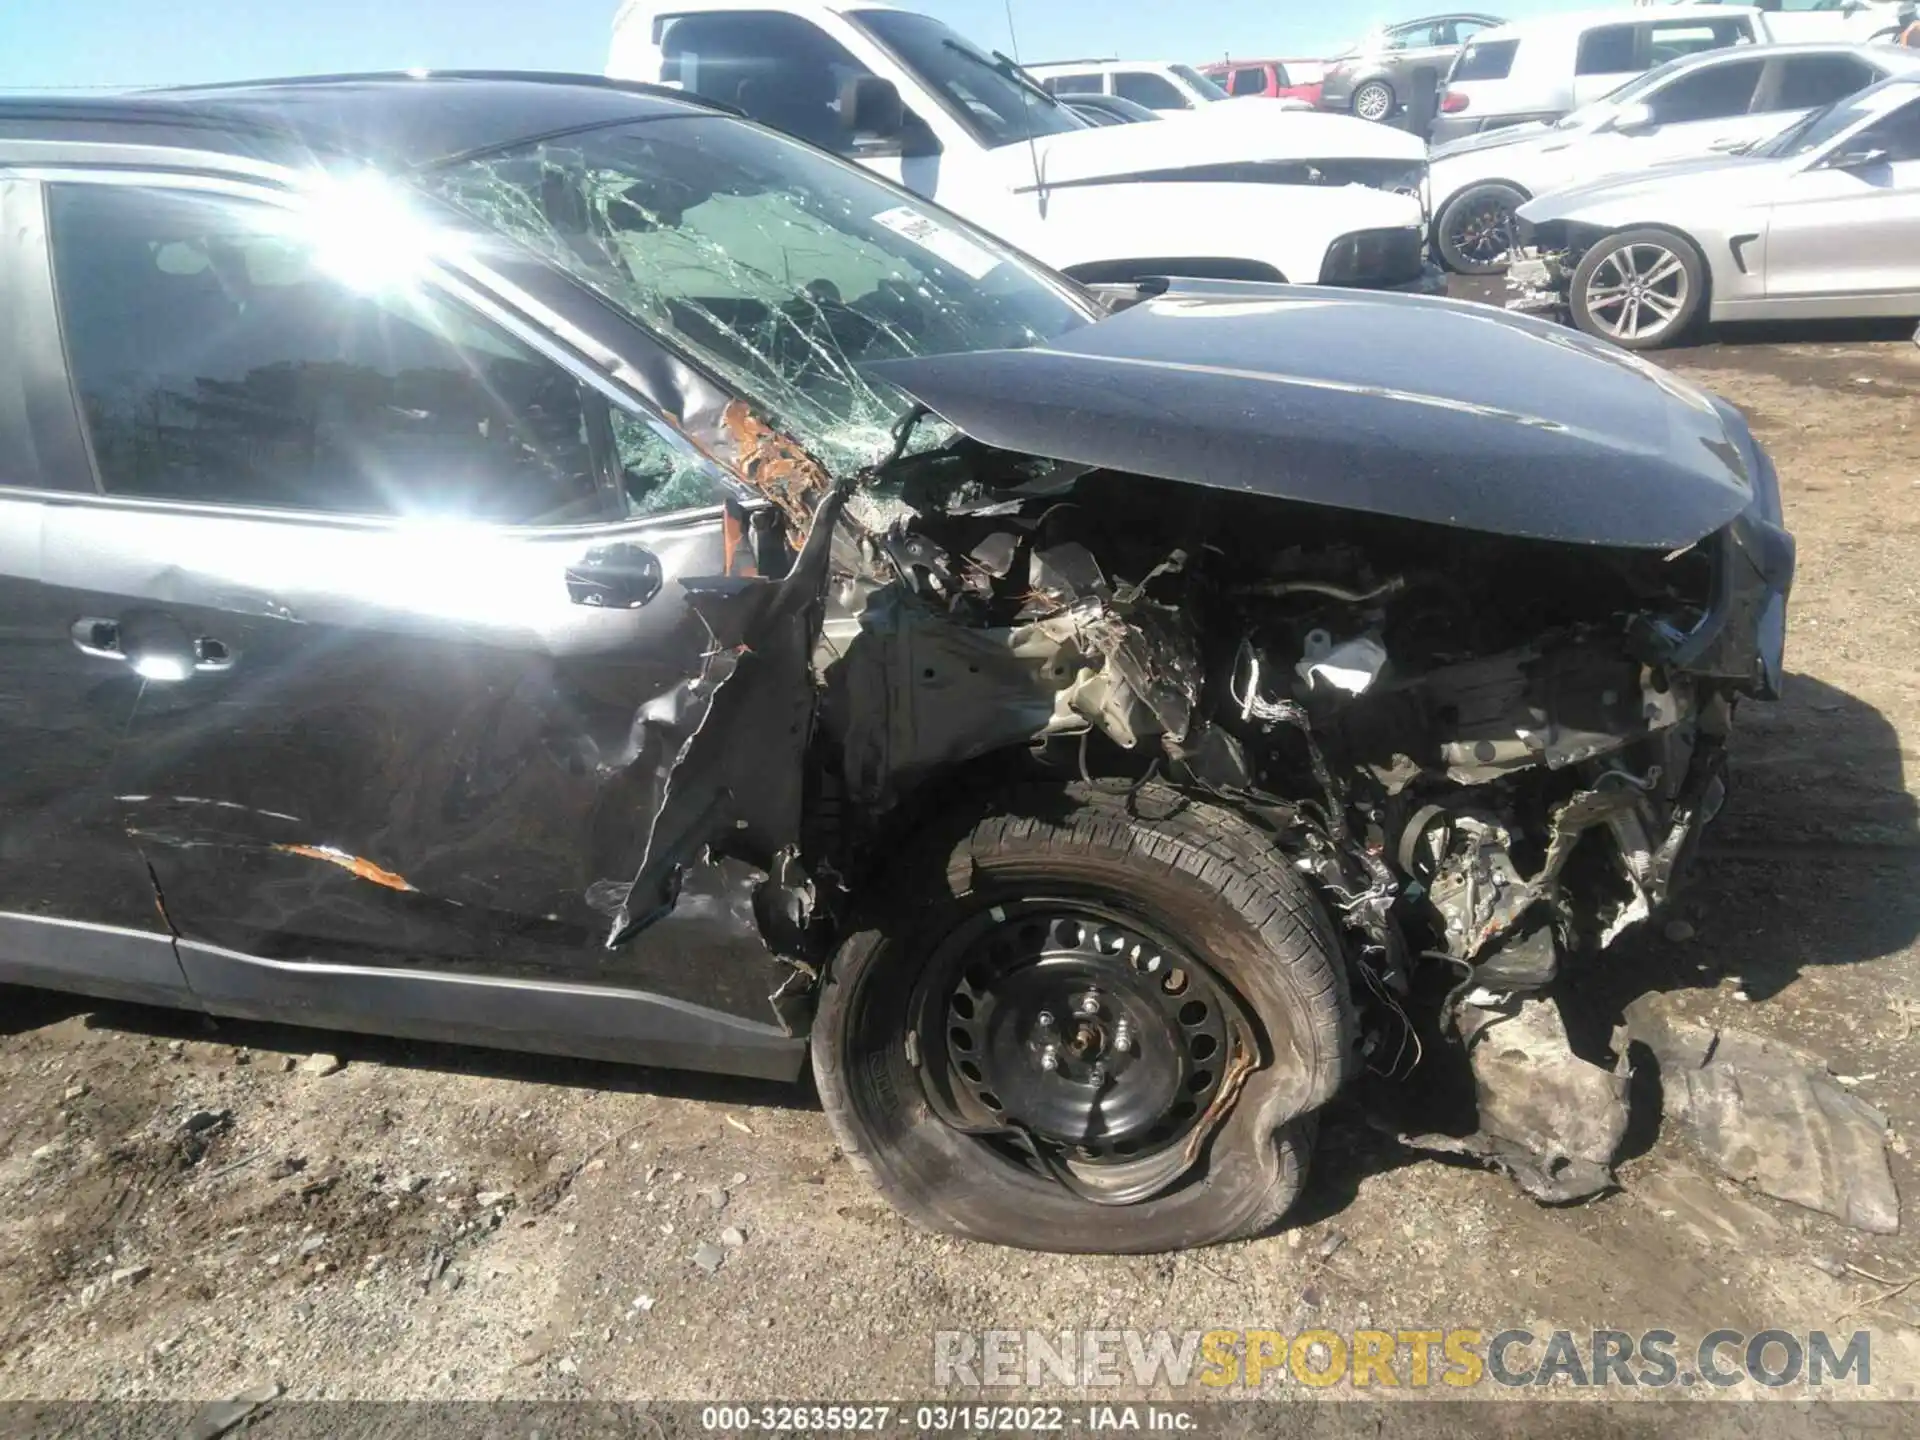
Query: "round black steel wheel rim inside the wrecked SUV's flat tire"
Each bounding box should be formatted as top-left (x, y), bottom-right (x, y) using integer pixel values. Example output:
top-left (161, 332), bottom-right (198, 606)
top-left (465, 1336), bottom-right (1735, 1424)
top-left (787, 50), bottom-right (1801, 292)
top-left (943, 906), bottom-right (1233, 1164)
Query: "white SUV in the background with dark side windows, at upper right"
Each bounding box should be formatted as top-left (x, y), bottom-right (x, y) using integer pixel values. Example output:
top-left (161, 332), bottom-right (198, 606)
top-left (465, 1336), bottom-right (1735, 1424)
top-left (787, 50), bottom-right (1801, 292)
top-left (1430, 4), bottom-right (1772, 146)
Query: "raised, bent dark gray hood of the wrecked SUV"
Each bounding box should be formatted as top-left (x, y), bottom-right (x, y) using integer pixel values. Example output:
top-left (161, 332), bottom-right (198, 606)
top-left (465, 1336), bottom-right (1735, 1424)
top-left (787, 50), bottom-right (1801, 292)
top-left (870, 282), bottom-right (1755, 549)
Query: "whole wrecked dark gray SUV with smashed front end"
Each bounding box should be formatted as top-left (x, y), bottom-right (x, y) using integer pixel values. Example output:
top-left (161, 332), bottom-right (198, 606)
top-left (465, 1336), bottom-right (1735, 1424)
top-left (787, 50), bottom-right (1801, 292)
top-left (0, 75), bottom-right (1793, 1252)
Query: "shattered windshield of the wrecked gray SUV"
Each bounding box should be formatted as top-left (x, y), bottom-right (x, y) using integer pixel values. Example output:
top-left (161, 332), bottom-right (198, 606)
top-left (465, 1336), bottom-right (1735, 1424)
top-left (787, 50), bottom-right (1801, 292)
top-left (430, 115), bottom-right (1092, 470)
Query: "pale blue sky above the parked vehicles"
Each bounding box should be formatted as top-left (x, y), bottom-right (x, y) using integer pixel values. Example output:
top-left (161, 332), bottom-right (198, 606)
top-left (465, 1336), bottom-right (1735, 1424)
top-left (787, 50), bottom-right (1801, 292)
top-left (0, 0), bottom-right (1624, 90)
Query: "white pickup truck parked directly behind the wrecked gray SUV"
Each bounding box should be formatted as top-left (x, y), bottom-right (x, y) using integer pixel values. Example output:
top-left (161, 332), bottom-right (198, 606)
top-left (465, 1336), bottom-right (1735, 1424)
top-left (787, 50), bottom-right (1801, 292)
top-left (607, 0), bottom-right (1440, 290)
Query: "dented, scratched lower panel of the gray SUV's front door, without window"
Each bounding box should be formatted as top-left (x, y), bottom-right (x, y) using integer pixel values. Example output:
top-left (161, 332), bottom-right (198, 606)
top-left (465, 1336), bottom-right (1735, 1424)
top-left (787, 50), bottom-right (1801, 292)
top-left (67, 509), bottom-right (787, 1020)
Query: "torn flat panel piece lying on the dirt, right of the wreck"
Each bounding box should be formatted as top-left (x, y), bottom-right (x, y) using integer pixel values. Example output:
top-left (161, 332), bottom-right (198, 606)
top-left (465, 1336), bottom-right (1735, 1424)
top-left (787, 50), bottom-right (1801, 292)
top-left (1626, 995), bottom-right (1901, 1235)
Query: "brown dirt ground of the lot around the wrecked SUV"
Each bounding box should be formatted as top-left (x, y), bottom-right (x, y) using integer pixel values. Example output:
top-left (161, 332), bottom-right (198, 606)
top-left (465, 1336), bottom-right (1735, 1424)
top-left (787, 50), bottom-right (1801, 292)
top-left (0, 305), bottom-right (1920, 1400)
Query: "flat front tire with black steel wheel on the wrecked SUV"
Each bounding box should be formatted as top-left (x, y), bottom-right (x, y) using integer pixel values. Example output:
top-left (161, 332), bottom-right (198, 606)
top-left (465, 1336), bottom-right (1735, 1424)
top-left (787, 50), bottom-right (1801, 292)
top-left (812, 785), bottom-right (1354, 1254)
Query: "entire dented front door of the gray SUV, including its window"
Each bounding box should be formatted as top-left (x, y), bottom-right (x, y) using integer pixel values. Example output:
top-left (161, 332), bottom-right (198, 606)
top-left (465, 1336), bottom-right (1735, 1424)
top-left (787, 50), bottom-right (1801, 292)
top-left (40, 177), bottom-right (797, 1029)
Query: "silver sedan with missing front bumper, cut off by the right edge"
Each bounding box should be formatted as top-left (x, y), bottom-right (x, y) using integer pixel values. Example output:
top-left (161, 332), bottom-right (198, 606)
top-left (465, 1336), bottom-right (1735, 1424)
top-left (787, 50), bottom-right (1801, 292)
top-left (1507, 77), bottom-right (1920, 349)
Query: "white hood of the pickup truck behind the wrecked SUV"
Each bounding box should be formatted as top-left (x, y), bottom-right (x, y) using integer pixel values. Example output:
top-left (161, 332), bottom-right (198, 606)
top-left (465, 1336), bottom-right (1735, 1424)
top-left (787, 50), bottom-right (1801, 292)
top-left (989, 106), bottom-right (1427, 188)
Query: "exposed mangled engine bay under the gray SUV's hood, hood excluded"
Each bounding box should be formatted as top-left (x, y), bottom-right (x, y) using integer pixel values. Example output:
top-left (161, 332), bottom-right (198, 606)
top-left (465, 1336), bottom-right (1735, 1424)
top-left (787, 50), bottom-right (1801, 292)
top-left (710, 442), bottom-right (1758, 1200)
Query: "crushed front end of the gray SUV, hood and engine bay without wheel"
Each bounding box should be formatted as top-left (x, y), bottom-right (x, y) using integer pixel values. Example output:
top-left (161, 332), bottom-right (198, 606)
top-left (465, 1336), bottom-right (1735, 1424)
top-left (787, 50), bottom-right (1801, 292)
top-left (576, 272), bottom-right (1793, 1202)
